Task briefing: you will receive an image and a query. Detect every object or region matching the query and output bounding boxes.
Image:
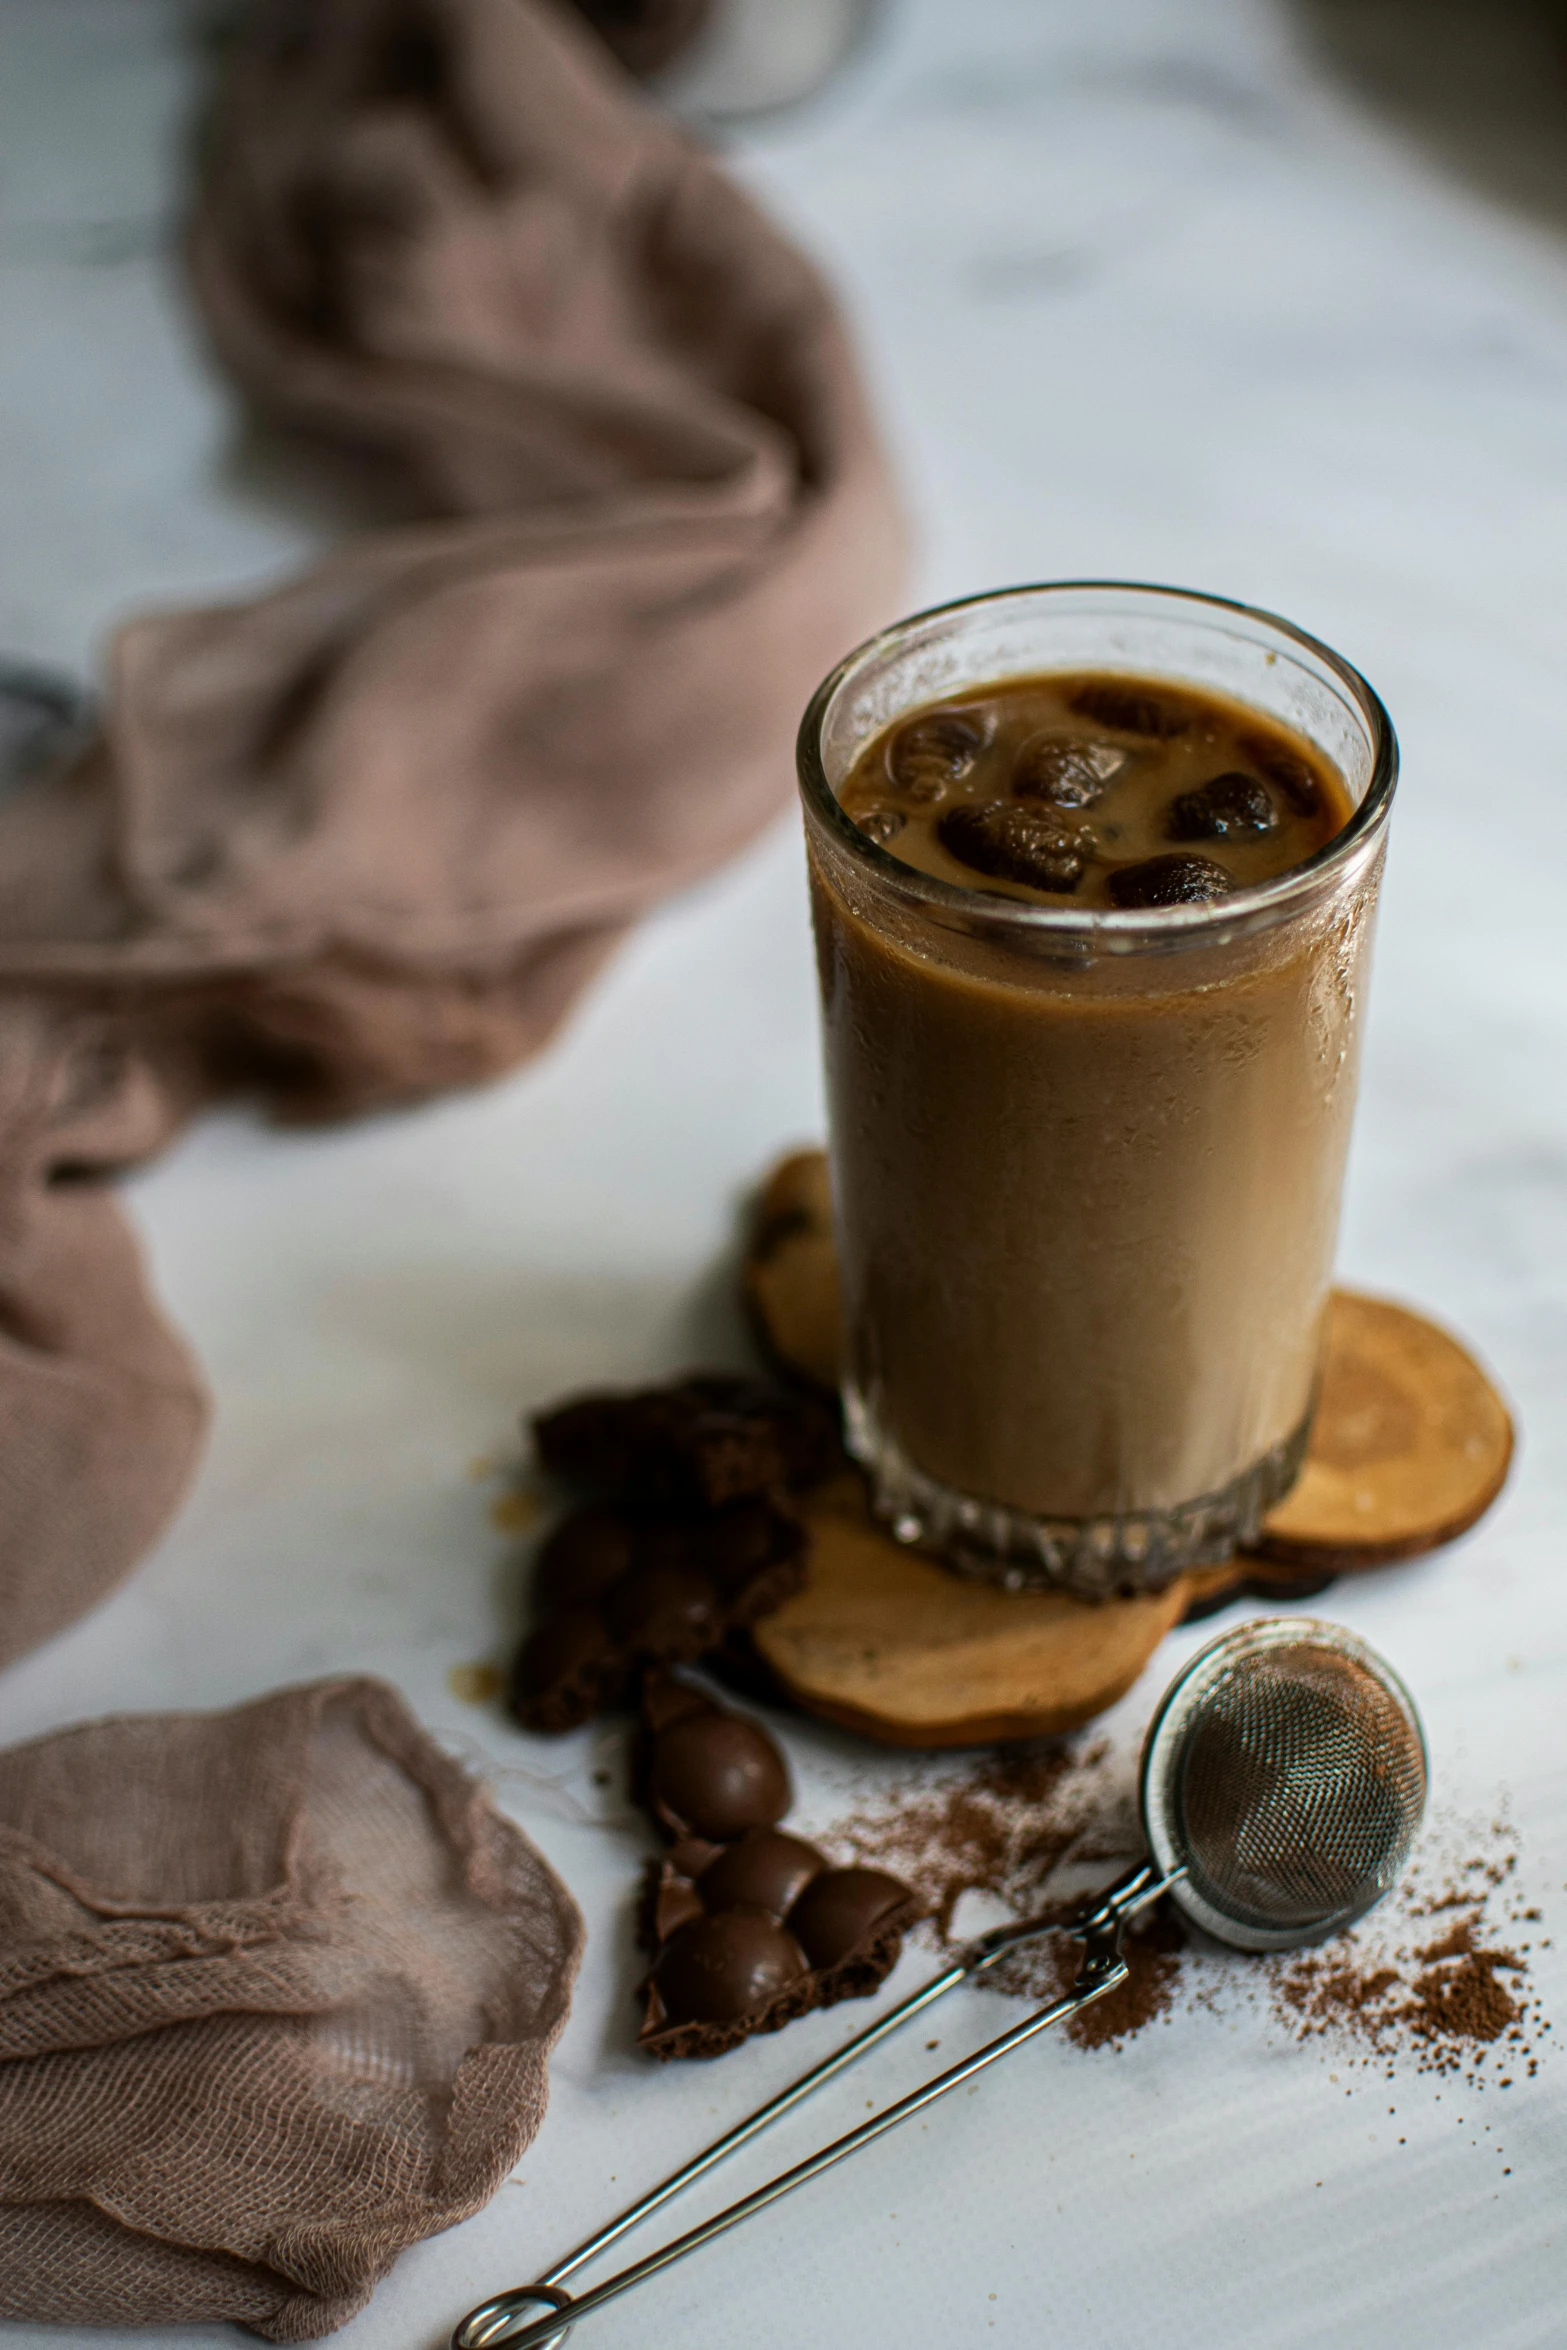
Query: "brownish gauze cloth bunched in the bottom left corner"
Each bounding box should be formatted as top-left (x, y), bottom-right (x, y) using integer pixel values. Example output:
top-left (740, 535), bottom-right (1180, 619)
top-left (0, 1680), bottom-right (583, 2343)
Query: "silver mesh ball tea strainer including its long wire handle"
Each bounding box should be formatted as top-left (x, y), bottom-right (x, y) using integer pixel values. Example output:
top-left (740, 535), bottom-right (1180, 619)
top-left (451, 1617), bottom-right (1426, 2350)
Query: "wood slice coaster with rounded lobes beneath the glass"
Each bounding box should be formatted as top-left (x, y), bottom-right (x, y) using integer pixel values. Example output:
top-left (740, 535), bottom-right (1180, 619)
top-left (745, 1152), bottom-right (1513, 1746)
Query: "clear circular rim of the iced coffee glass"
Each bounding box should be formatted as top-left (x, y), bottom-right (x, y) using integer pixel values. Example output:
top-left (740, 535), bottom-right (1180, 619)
top-left (794, 580), bottom-right (1398, 949)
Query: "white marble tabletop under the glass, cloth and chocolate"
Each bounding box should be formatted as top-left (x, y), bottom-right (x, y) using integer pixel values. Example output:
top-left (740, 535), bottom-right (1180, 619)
top-left (0, 0), bottom-right (1567, 2350)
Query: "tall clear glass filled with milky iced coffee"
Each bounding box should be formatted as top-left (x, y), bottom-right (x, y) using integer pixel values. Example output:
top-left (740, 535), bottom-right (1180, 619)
top-left (799, 583), bottom-right (1398, 1596)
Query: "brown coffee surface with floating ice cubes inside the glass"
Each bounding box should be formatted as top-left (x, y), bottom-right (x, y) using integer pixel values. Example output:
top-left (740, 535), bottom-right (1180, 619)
top-left (839, 672), bottom-right (1351, 907)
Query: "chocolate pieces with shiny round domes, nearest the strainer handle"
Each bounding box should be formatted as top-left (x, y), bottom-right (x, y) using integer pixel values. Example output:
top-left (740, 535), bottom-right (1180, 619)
top-left (637, 1673), bottom-right (921, 2061)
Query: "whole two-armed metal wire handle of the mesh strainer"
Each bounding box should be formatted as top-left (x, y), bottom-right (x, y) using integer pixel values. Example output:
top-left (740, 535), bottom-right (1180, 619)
top-left (451, 1861), bottom-right (1169, 2350)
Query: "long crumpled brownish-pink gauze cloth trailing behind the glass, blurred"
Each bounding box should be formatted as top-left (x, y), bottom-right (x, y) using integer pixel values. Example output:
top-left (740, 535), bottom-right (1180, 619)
top-left (0, 0), bottom-right (902, 1664)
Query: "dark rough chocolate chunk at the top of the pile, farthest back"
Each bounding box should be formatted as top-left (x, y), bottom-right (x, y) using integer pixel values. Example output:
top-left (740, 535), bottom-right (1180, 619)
top-left (533, 1372), bottom-right (839, 1509)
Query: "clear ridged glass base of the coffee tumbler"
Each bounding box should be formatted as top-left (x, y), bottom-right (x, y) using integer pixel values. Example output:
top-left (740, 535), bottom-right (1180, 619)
top-left (843, 1382), bottom-right (1311, 1600)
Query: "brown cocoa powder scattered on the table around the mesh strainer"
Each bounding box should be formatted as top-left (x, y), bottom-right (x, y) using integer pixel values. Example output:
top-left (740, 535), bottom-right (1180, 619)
top-left (822, 1744), bottom-right (1551, 2087)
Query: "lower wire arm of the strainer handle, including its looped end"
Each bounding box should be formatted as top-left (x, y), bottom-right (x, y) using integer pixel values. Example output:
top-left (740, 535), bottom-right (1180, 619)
top-left (451, 1915), bottom-right (1128, 2350)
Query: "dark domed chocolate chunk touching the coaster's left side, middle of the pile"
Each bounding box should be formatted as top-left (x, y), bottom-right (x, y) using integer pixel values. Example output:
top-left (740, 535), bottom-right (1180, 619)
top-left (510, 1502), bottom-right (808, 1730)
